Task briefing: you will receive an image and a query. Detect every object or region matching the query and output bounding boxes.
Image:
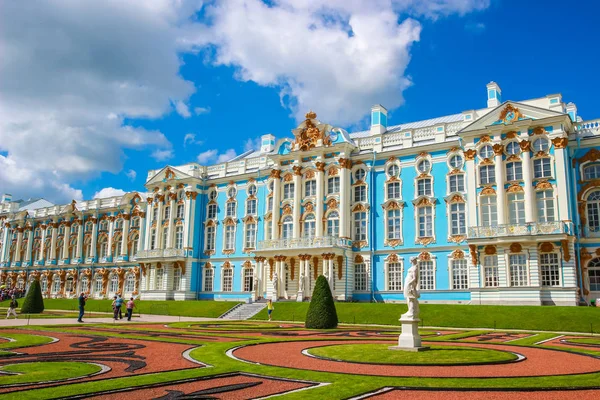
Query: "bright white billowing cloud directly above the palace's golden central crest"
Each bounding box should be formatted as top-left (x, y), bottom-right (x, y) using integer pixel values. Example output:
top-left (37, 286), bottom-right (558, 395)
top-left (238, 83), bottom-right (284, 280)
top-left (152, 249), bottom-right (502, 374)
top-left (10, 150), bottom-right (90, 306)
top-left (187, 0), bottom-right (489, 124)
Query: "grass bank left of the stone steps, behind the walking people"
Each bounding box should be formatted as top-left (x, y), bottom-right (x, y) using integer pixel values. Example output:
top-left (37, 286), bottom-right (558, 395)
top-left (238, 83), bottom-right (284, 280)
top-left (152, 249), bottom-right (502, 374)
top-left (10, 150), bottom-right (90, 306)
top-left (0, 299), bottom-right (239, 318)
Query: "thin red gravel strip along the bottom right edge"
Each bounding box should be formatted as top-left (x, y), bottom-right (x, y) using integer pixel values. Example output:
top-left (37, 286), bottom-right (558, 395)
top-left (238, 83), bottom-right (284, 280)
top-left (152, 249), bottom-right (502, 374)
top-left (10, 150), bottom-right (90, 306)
top-left (367, 390), bottom-right (600, 400)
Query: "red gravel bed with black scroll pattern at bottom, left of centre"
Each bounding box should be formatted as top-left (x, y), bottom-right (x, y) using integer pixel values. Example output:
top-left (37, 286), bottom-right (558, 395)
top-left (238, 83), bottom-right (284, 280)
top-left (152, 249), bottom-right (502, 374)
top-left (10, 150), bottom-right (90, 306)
top-left (90, 375), bottom-right (311, 400)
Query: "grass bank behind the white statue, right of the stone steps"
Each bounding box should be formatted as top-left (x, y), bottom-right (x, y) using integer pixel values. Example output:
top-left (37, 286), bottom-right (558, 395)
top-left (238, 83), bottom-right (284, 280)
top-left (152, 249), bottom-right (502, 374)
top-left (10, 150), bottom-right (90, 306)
top-left (253, 302), bottom-right (600, 333)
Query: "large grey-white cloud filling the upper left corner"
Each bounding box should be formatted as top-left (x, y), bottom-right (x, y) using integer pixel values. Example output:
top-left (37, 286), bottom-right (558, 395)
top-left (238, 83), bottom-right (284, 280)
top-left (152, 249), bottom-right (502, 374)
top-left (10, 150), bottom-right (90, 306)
top-left (0, 0), bottom-right (201, 201)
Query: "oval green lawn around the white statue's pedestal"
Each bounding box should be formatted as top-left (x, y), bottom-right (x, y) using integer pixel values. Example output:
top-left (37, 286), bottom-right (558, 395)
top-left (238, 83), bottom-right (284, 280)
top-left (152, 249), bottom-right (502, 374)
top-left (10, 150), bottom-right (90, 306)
top-left (308, 344), bottom-right (517, 365)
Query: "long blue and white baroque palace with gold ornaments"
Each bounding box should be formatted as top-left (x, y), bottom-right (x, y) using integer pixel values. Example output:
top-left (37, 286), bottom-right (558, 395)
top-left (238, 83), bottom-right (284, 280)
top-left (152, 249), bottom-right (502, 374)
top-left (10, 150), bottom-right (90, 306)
top-left (0, 82), bottom-right (600, 305)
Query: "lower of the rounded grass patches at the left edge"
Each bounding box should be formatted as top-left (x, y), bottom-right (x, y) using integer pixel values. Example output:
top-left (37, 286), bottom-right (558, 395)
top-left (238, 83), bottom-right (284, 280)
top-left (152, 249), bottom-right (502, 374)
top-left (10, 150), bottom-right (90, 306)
top-left (0, 362), bottom-right (101, 386)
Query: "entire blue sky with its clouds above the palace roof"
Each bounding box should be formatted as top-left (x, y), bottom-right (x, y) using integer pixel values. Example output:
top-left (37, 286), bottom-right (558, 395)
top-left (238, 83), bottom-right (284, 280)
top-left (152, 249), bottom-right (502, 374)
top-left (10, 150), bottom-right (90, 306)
top-left (0, 0), bottom-right (600, 201)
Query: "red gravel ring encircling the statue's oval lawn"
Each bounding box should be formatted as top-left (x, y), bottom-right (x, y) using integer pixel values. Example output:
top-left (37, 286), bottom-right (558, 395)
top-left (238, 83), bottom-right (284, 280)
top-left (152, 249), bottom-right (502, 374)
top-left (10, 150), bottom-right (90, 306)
top-left (233, 340), bottom-right (600, 378)
